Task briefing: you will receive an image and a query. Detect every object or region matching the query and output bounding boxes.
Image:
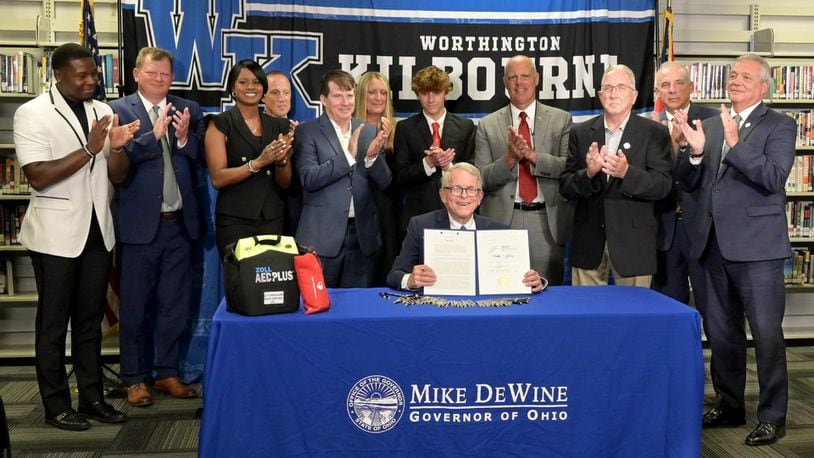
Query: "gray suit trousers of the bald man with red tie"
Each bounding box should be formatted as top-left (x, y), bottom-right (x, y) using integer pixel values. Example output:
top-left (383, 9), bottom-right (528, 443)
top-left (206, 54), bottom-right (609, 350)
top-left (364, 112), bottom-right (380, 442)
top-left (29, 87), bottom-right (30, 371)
top-left (511, 208), bottom-right (565, 286)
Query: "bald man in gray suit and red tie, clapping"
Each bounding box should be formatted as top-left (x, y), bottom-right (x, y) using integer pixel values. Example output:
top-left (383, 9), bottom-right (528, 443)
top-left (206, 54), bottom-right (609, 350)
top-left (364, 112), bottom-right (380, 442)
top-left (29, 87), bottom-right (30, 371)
top-left (475, 56), bottom-right (573, 285)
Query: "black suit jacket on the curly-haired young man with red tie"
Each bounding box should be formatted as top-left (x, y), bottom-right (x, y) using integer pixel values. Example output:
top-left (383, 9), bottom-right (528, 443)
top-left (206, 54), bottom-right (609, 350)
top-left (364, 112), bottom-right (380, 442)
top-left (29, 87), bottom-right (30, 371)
top-left (393, 111), bottom-right (475, 230)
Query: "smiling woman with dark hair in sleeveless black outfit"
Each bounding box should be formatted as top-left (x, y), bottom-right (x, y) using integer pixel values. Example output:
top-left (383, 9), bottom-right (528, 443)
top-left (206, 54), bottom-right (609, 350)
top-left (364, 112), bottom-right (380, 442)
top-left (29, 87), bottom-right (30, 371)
top-left (205, 60), bottom-right (294, 257)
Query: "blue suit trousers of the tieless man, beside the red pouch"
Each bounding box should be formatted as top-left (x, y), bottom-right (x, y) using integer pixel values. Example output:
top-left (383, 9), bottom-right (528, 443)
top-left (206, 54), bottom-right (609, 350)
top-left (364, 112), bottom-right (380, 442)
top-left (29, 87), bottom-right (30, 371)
top-left (324, 220), bottom-right (373, 288)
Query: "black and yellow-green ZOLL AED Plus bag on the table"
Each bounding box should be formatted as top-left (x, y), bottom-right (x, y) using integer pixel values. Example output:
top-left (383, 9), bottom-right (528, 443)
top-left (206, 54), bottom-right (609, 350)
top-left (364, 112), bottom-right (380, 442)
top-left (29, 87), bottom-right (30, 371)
top-left (223, 235), bottom-right (300, 316)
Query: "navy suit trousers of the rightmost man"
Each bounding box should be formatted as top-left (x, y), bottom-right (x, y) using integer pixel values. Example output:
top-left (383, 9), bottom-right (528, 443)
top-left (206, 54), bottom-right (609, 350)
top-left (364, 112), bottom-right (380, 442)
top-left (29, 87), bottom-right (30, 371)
top-left (700, 231), bottom-right (788, 425)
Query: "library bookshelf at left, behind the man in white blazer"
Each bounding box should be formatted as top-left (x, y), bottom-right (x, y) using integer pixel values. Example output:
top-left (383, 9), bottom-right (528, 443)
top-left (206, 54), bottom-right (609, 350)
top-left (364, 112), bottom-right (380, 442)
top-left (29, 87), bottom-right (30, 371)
top-left (0, 0), bottom-right (119, 358)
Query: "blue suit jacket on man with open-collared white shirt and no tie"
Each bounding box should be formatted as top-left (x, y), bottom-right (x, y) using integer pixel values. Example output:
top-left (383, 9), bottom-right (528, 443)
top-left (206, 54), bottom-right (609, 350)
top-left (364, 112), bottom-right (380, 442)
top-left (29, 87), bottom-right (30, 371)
top-left (294, 114), bottom-right (391, 257)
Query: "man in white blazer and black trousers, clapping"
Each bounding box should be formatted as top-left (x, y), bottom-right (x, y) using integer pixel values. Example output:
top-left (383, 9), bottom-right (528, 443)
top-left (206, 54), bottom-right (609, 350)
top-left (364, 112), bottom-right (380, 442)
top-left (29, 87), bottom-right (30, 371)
top-left (14, 43), bottom-right (138, 430)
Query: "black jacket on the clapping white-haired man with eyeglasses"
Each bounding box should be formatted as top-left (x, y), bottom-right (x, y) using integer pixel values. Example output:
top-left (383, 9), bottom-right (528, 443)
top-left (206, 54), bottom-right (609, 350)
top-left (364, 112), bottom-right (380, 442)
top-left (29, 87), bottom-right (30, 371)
top-left (560, 115), bottom-right (672, 277)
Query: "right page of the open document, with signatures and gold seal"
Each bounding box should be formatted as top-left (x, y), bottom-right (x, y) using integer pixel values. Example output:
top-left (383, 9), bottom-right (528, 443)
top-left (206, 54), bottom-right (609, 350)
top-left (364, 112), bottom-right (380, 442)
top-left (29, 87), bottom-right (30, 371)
top-left (477, 229), bottom-right (531, 294)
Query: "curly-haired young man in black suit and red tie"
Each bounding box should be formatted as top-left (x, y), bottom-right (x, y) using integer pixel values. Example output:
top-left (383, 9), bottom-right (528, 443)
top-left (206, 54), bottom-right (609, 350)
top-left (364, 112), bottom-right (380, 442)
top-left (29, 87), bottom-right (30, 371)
top-left (393, 65), bottom-right (475, 238)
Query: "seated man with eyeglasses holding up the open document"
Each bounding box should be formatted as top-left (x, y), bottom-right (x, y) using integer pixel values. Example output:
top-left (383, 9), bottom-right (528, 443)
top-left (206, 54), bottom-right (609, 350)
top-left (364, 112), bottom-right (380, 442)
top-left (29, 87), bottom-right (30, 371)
top-left (387, 162), bottom-right (543, 292)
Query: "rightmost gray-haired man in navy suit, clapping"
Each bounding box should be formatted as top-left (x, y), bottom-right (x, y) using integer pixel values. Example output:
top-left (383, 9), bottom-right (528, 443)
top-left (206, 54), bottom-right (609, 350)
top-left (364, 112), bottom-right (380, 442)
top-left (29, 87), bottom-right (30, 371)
top-left (676, 54), bottom-right (797, 445)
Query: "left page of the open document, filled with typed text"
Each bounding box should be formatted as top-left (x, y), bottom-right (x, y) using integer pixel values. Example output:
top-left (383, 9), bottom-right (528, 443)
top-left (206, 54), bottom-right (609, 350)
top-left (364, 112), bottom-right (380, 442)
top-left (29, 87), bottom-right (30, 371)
top-left (424, 229), bottom-right (477, 296)
